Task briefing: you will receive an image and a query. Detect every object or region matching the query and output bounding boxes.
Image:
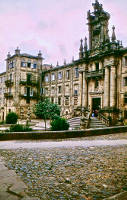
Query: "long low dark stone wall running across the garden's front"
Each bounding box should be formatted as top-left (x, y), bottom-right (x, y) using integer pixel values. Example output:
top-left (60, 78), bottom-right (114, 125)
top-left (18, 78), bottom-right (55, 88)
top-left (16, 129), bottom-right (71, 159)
top-left (0, 126), bottom-right (127, 141)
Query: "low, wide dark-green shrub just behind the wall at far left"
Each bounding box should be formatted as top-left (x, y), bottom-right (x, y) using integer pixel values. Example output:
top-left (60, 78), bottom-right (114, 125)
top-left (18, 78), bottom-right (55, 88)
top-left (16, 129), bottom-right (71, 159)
top-left (9, 124), bottom-right (32, 132)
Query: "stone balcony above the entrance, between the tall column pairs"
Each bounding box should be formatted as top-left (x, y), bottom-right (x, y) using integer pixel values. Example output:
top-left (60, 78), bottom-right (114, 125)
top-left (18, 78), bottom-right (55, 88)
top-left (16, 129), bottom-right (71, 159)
top-left (85, 69), bottom-right (104, 79)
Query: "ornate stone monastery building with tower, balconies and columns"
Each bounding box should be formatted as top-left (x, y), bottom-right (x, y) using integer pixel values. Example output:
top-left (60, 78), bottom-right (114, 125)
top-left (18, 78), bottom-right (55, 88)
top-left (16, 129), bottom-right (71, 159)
top-left (0, 0), bottom-right (127, 120)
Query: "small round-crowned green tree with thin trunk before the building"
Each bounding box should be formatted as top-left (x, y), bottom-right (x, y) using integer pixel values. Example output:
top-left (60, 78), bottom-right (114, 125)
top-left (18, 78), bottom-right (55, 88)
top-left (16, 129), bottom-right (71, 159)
top-left (34, 98), bottom-right (60, 130)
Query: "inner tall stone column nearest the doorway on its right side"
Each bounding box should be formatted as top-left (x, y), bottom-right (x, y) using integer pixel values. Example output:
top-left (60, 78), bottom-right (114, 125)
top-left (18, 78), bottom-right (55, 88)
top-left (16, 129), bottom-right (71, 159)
top-left (103, 66), bottom-right (110, 107)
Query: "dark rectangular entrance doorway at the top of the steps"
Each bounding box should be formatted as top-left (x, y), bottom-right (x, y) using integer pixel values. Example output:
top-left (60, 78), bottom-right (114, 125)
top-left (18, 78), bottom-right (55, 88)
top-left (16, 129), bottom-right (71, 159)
top-left (92, 98), bottom-right (101, 117)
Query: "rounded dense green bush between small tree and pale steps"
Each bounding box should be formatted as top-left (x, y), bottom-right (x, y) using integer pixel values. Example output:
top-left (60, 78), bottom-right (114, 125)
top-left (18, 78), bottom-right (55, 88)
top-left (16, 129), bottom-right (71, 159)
top-left (51, 117), bottom-right (69, 131)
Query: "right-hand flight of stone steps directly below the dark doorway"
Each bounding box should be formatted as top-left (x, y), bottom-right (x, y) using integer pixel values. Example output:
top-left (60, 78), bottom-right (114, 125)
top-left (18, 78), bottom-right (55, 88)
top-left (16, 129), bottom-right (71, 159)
top-left (89, 117), bottom-right (107, 129)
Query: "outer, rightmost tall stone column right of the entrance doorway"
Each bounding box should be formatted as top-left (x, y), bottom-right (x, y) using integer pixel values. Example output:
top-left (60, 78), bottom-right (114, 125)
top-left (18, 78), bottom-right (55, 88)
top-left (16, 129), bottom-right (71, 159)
top-left (110, 66), bottom-right (116, 107)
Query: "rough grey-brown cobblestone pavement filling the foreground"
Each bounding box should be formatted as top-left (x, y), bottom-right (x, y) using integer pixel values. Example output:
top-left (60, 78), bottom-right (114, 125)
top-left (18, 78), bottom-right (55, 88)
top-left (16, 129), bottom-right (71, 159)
top-left (0, 133), bottom-right (127, 200)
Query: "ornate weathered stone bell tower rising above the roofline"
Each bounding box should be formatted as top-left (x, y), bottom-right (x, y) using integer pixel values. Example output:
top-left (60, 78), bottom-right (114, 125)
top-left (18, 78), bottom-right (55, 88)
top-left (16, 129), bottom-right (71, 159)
top-left (87, 0), bottom-right (110, 50)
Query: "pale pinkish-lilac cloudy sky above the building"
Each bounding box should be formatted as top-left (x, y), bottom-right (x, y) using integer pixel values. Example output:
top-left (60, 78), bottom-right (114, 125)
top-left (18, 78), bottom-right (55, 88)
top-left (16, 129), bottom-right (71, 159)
top-left (0, 0), bottom-right (127, 72)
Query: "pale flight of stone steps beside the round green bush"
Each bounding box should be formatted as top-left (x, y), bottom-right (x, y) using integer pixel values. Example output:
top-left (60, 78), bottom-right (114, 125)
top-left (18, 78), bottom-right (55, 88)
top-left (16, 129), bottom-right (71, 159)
top-left (68, 117), bottom-right (81, 130)
